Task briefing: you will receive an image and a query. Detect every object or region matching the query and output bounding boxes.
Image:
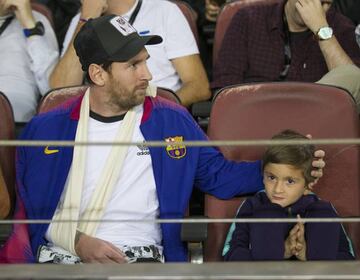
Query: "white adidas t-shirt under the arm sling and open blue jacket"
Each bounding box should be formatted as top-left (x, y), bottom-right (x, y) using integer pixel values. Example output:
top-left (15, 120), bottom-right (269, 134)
top-left (46, 105), bottom-right (162, 251)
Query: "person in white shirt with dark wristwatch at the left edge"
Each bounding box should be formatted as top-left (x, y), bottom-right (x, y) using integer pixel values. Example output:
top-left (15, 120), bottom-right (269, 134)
top-left (0, 0), bottom-right (59, 123)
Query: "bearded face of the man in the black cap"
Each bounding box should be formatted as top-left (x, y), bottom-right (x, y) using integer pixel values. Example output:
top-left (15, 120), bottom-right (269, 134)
top-left (105, 48), bottom-right (152, 111)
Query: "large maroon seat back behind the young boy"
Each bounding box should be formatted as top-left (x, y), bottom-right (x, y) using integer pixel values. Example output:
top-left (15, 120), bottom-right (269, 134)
top-left (205, 82), bottom-right (360, 261)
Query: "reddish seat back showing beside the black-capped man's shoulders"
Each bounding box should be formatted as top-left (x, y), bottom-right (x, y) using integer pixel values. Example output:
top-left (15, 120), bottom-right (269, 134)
top-left (37, 85), bottom-right (180, 113)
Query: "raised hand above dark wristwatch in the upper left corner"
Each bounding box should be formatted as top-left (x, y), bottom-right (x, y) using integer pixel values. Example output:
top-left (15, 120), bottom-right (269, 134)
top-left (0, 0), bottom-right (36, 29)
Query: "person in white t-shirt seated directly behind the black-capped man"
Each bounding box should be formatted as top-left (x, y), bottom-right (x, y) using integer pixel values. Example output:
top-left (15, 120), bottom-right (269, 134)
top-left (50, 0), bottom-right (211, 106)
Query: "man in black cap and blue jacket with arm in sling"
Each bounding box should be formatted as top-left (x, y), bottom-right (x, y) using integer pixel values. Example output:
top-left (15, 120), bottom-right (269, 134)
top-left (0, 15), bottom-right (324, 263)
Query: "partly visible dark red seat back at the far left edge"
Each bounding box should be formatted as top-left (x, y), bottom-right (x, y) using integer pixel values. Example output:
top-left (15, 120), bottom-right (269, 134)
top-left (0, 92), bottom-right (15, 212)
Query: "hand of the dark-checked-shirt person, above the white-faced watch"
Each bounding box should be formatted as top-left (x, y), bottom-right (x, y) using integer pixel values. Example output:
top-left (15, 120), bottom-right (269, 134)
top-left (295, 0), bottom-right (331, 34)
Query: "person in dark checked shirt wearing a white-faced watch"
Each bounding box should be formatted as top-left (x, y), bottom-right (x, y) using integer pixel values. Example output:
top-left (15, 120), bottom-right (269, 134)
top-left (212, 0), bottom-right (360, 89)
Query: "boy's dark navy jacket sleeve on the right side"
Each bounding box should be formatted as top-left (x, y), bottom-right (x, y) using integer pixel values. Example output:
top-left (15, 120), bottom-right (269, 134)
top-left (305, 200), bottom-right (354, 260)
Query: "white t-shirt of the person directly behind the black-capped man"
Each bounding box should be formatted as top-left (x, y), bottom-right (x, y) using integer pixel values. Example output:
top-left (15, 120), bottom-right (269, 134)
top-left (63, 0), bottom-right (199, 91)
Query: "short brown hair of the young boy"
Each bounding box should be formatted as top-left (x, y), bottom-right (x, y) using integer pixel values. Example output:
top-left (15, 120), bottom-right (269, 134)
top-left (262, 129), bottom-right (315, 185)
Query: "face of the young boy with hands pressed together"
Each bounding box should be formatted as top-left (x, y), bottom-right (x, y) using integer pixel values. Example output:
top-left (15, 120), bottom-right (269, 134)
top-left (264, 163), bottom-right (307, 207)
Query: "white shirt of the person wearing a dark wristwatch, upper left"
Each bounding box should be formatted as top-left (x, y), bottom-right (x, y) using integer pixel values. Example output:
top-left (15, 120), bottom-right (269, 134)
top-left (0, 11), bottom-right (59, 122)
